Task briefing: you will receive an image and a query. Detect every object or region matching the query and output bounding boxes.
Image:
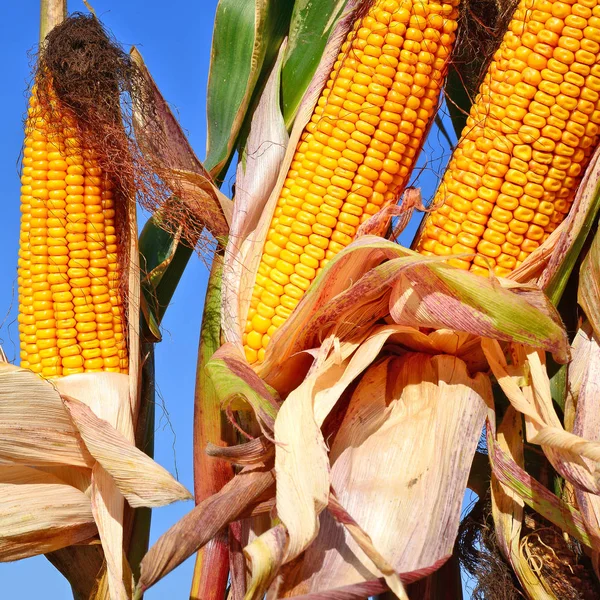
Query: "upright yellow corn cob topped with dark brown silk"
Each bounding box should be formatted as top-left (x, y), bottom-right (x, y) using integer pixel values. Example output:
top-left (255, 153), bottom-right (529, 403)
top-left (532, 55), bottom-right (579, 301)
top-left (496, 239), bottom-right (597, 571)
top-left (18, 89), bottom-right (128, 377)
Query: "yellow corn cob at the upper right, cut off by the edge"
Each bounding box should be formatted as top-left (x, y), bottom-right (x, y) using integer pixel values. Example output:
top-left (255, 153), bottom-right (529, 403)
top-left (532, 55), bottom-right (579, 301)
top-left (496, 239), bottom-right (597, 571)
top-left (416, 0), bottom-right (600, 276)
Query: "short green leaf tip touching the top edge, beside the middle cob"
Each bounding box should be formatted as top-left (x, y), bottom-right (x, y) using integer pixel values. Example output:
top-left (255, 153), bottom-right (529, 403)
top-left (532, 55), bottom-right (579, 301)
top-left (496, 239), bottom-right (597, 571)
top-left (281, 0), bottom-right (347, 129)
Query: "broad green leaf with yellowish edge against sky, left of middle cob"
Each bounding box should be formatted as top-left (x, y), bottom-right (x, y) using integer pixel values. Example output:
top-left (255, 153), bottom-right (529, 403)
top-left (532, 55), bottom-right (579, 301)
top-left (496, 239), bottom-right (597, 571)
top-left (204, 0), bottom-right (291, 177)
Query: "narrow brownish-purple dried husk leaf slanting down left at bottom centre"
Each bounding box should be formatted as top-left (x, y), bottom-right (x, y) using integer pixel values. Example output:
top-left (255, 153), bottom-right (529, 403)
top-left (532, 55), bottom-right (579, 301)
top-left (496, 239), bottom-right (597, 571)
top-left (137, 468), bottom-right (275, 597)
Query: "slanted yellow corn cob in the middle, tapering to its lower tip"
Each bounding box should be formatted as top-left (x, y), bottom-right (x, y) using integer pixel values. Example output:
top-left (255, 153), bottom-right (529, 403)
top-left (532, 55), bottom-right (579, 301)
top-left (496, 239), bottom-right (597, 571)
top-left (244, 0), bottom-right (458, 362)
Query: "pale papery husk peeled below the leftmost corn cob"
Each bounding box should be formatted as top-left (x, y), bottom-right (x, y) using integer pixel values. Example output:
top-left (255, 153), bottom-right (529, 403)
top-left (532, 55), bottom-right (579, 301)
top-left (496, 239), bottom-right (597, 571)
top-left (0, 363), bottom-right (190, 599)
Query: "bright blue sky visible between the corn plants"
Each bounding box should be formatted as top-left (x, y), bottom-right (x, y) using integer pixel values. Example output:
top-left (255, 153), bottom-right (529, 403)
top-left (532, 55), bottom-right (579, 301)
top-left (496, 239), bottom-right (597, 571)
top-left (0, 0), bottom-right (464, 600)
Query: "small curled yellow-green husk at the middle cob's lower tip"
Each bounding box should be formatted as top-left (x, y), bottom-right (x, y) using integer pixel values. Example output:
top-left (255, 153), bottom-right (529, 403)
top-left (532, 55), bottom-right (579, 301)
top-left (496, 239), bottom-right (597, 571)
top-left (206, 344), bottom-right (278, 435)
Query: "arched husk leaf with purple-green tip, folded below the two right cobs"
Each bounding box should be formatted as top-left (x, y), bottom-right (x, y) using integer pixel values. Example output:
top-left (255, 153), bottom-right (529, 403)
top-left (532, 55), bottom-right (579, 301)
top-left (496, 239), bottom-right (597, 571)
top-left (257, 236), bottom-right (568, 377)
